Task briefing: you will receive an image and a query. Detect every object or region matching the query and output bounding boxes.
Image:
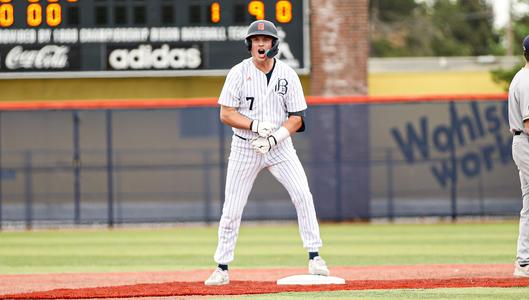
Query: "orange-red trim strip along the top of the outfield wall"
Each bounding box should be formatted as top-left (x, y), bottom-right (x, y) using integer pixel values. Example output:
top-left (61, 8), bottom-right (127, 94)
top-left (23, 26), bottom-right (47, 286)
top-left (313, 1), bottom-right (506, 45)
top-left (0, 93), bottom-right (507, 111)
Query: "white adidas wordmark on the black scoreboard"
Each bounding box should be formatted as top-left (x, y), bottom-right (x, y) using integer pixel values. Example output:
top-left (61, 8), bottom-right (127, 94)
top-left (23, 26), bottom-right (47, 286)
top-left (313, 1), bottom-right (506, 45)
top-left (108, 44), bottom-right (202, 70)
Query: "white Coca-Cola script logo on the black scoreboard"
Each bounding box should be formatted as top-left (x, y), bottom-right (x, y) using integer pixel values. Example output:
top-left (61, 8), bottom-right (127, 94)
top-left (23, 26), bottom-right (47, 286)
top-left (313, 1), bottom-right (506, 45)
top-left (5, 45), bottom-right (70, 70)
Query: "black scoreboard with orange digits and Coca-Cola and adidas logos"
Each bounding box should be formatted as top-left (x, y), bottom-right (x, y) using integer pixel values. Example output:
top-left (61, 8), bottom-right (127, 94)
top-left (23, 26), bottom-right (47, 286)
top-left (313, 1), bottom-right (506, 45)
top-left (0, 0), bottom-right (309, 78)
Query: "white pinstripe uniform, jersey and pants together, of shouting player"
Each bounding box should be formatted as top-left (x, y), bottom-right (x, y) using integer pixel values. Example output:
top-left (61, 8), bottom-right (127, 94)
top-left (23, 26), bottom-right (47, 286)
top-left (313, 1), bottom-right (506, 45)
top-left (214, 58), bottom-right (322, 264)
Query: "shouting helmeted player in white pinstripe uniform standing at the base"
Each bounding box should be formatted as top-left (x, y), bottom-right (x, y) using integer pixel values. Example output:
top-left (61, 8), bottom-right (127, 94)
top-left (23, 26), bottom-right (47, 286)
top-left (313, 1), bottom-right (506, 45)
top-left (204, 20), bottom-right (329, 285)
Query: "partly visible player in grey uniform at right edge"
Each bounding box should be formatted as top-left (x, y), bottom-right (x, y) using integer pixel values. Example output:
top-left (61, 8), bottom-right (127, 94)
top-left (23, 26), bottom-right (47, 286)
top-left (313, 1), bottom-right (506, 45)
top-left (509, 36), bottom-right (529, 277)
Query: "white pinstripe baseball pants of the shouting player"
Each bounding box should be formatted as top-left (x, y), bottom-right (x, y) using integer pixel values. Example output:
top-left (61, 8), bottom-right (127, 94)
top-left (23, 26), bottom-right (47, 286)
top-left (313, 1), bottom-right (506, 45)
top-left (214, 136), bottom-right (322, 264)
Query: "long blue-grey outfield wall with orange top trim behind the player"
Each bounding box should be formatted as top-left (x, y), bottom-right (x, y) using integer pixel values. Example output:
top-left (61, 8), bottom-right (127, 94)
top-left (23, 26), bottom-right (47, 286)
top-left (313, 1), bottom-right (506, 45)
top-left (0, 94), bottom-right (521, 227)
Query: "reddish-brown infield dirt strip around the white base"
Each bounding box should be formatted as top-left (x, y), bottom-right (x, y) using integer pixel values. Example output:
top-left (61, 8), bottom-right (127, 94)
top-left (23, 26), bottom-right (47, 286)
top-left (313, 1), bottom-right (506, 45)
top-left (0, 264), bottom-right (529, 299)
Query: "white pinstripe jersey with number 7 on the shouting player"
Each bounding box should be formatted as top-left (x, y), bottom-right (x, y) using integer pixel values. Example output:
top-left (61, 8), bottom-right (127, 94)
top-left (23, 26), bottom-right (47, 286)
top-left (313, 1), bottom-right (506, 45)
top-left (218, 58), bottom-right (307, 139)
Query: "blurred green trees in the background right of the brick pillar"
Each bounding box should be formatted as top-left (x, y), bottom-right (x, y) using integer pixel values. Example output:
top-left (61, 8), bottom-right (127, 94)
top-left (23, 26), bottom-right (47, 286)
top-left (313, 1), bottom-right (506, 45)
top-left (369, 0), bottom-right (503, 57)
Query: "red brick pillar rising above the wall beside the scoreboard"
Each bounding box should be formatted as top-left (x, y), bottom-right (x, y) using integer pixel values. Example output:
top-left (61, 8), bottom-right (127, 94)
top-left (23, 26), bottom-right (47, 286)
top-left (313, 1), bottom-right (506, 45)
top-left (310, 0), bottom-right (369, 96)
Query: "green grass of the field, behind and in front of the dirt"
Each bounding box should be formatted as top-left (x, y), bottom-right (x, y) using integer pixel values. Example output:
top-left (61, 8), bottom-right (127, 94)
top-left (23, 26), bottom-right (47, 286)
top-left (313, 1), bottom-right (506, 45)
top-left (0, 221), bottom-right (529, 299)
